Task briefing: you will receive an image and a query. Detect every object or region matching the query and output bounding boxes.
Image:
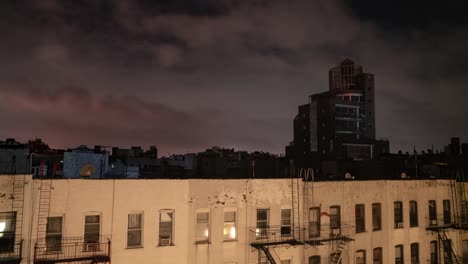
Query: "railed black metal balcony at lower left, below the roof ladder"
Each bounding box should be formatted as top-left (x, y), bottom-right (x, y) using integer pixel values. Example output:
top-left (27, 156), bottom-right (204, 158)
top-left (34, 236), bottom-right (111, 264)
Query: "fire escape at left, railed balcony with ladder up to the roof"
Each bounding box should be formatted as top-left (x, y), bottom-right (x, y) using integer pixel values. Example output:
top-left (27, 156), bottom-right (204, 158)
top-left (34, 158), bottom-right (111, 264)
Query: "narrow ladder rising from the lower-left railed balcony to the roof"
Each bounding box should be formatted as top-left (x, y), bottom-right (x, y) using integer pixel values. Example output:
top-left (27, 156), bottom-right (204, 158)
top-left (36, 174), bottom-right (52, 240)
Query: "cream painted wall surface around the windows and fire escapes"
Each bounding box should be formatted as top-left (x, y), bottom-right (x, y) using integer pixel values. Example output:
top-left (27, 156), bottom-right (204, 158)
top-left (0, 175), bottom-right (468, 264)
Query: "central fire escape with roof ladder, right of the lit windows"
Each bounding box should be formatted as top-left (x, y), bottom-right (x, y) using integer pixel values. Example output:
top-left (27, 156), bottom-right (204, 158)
top-left (250, 166), bottom-right (353, 264)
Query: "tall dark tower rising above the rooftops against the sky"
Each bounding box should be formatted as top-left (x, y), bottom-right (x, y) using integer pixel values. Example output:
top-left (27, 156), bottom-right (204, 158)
top-left (294, 59), bottom-right (384, 159)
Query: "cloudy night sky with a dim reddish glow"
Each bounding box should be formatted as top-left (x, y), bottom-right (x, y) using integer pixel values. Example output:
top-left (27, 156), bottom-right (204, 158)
top-left (0, 0), bottom-right (468, 155)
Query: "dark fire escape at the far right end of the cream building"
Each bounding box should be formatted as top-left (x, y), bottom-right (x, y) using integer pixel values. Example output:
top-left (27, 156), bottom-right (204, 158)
top-left (426, 170), bottom-right (468, 264)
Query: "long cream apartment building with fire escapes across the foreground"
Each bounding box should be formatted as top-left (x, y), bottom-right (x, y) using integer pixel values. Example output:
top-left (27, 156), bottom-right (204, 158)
top-left (0, 175), bottom-right (468, 264)
